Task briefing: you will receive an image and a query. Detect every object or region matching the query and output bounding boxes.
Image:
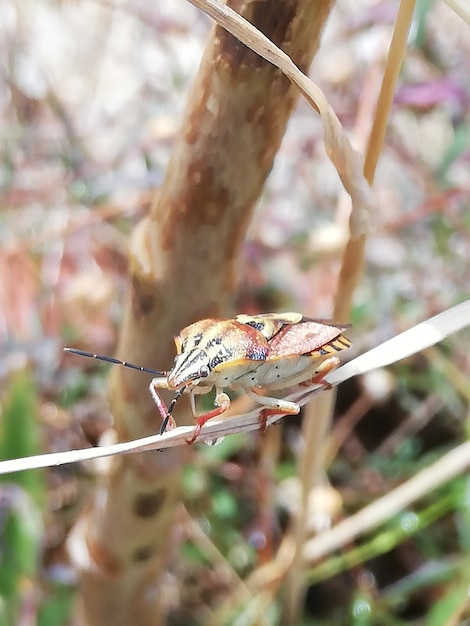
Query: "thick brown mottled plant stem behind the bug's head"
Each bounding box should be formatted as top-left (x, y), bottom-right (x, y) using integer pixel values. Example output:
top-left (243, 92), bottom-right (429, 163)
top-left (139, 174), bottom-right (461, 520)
top-left (70, 0), bottom-right (331, 626)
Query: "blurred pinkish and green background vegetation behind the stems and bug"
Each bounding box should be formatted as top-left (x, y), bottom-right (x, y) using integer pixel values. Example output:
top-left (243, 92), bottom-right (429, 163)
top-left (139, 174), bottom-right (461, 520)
top-left (0, 0), bottom-right (470, 626)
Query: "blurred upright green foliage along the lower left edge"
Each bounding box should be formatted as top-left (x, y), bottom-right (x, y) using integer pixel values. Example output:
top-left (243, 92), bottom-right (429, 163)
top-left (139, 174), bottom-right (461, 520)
top-left (0, 370), bottom-right (73, 626)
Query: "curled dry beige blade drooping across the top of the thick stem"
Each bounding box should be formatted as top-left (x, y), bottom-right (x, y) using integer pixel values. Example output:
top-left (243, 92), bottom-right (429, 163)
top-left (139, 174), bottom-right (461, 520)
top-left (185, 0), bottom-right (372, 238)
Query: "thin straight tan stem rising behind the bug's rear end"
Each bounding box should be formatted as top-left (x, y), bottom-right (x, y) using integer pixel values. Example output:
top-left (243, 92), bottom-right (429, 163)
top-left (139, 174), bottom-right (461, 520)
top-left (285, 0), bottom-right (414, 624)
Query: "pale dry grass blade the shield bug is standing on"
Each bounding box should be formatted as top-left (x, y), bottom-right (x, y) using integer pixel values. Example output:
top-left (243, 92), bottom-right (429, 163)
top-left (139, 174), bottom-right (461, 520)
top-left (0, 300), bottom-right (470, 474)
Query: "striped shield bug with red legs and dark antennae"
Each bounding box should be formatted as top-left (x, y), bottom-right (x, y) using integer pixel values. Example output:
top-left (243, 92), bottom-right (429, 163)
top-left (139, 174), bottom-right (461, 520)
top-left (64, 313), bottom-right (351, 444)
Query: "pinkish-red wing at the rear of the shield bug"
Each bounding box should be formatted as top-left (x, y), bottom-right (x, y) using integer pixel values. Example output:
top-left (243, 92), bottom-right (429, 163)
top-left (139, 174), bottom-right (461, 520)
top-left (268, 319), bottom-right (351, 360)
